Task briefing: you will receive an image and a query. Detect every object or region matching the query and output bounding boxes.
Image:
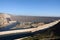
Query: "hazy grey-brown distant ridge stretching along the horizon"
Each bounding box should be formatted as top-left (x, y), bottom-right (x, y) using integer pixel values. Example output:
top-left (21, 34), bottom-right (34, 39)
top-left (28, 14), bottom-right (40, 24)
top-left (0, 13), bottom-right (60, 23)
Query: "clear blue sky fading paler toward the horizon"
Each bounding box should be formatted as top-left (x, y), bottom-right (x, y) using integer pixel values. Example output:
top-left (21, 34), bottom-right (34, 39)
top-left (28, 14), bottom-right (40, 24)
top-left (0, 0), bottom-right (60, 17)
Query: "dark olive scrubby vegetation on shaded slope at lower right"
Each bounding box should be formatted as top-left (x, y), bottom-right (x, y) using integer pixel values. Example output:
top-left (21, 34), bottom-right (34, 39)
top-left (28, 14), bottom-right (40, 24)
top-left (22, 29), bottom-right (60, 40)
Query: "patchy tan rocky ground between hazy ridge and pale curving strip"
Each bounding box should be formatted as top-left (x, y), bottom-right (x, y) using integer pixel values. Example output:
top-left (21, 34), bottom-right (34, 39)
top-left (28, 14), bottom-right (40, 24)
top-left (12, 22), bottom-right (45, 29)
